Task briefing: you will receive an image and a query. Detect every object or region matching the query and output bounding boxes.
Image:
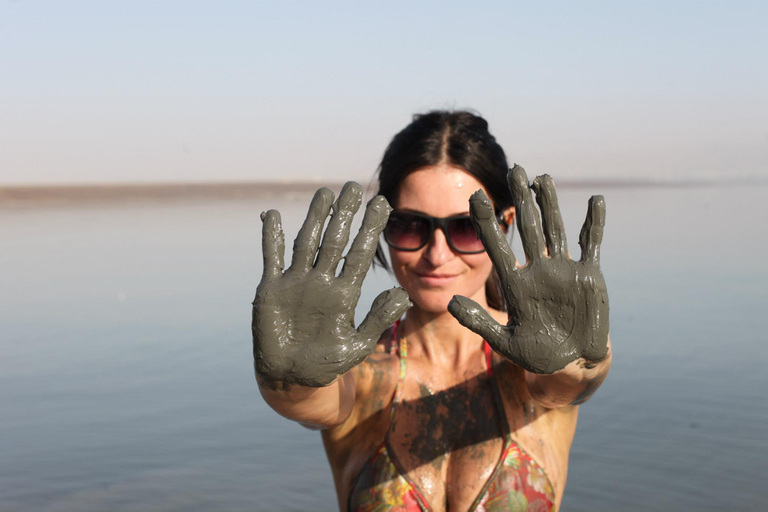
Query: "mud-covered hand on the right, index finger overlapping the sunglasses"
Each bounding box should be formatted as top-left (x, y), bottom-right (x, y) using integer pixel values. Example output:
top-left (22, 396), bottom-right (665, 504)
top-left (448, 165), bottom-right (608, 373)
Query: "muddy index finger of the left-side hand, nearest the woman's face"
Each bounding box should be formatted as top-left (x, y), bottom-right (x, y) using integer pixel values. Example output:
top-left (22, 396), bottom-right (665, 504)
top-left (341, 196), bottom-right (392, 284)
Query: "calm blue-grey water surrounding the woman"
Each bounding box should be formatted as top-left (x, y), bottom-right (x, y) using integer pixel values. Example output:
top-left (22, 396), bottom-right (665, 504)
top-left (0, 183), bottom-right (768, 511)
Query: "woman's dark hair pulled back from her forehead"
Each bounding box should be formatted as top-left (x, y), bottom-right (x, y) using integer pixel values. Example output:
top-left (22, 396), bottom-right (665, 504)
top-left (376, 110), bottom-right (512, 310)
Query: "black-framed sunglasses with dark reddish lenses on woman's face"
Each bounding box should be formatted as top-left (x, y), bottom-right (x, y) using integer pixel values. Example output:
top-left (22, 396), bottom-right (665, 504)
top-left (384, 211), bottom-right (503, 254)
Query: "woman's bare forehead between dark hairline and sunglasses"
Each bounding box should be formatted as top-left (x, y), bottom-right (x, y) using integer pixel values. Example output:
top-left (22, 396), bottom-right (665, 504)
top-left (393, 164), bottom-right (488, 217)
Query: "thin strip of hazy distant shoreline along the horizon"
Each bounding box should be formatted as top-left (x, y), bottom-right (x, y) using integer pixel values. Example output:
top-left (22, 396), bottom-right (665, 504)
top-left (0, 179), bottom-right (752, 208)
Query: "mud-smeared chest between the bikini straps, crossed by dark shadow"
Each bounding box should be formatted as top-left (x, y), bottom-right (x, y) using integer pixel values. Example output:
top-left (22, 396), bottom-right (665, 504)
top-left (388, 373), bottom-right (507, 510)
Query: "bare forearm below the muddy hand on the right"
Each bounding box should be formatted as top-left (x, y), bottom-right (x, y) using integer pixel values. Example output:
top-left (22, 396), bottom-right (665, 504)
top-left (525, 336), bottom-right (612, 409)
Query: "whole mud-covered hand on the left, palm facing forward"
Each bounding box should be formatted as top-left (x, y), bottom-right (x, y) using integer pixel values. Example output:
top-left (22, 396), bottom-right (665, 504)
top-left (252, 182), bottom-right (411, 387)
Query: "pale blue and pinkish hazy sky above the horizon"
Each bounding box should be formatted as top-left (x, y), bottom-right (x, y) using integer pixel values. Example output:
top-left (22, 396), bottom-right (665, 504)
top-left (0, 0), bottom-right (768, 185)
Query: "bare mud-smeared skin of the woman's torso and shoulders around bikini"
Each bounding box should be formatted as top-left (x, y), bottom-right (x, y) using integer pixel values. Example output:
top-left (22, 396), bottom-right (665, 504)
top-left (323, 326), bottom-right (577, 510)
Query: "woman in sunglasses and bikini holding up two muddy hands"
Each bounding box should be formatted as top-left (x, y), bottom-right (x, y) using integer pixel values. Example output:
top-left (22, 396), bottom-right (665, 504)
top-left (253, 112), bottom-right (611, 510)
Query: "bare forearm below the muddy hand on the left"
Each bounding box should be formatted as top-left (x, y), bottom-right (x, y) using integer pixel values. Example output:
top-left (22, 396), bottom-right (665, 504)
top-left (256, 372), bottom-right (355, 430)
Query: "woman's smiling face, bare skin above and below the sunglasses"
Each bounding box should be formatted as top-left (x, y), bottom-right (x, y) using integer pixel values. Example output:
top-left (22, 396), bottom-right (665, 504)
top-left (389, 164), bottom-right (492, 314)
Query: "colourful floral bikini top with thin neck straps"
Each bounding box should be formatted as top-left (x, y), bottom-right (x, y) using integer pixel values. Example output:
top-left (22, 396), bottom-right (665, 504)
top-left (347, 324), bottom-right (555, 512)
